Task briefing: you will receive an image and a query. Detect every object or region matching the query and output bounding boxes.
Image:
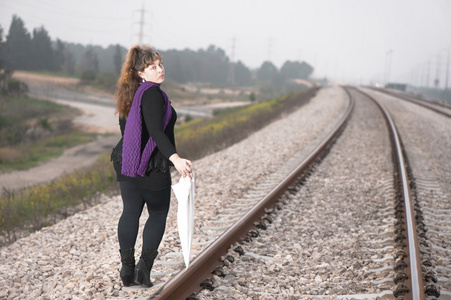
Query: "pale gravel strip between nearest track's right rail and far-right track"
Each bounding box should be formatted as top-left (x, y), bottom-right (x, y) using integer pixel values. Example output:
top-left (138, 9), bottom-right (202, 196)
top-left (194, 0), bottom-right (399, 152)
top-left (366, 89), bottom-right (451, 298)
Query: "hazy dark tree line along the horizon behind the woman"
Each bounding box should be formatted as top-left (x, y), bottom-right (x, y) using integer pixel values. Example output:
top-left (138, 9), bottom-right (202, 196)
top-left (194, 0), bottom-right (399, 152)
top-left (0, 15), bottom-right (313, 86)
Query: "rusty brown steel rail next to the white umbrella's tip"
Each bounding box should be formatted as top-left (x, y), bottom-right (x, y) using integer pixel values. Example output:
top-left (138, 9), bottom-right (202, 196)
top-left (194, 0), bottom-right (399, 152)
top-left (148, 89), bottom-right (354, 299)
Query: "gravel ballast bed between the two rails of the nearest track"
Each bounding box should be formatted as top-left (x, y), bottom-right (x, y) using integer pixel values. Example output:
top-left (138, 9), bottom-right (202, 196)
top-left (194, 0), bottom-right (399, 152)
top-left (198, 89), bottom-right (396, 299)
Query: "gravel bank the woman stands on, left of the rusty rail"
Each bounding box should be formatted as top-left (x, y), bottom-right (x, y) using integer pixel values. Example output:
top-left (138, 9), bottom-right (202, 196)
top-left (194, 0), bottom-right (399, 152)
top-left (0, 87), bottom-right (347, 299)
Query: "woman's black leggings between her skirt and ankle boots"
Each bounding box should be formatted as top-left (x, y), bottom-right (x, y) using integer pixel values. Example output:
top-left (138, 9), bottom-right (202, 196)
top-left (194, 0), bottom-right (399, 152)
top-left (117, 181), bottom-right (171, 250)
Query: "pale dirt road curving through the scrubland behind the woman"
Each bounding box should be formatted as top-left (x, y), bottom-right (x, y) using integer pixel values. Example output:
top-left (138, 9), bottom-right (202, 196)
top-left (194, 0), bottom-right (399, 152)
top-left (0, 71), bottom-right (251, 195)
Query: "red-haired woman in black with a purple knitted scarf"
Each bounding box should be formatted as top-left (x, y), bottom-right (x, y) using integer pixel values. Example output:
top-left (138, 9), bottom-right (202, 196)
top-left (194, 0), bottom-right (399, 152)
top-left (112, 45), bottom-right (191, 287)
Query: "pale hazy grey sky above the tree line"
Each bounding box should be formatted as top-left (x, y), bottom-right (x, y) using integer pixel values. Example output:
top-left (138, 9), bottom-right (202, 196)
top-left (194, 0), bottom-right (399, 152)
top-left (0, 0), bottom-right (451, 88)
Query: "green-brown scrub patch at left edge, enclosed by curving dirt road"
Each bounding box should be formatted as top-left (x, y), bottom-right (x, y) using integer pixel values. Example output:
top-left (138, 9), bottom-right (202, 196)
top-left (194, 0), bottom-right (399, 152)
top-left (0, 96), bottom-right (92, 171)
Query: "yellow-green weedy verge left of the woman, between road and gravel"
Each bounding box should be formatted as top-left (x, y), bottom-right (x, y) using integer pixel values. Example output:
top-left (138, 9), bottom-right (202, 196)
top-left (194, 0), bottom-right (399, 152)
top-left (0, 154), bottom-right (118, 242)
